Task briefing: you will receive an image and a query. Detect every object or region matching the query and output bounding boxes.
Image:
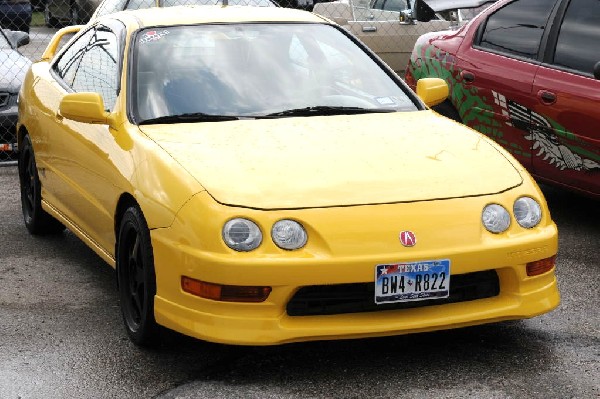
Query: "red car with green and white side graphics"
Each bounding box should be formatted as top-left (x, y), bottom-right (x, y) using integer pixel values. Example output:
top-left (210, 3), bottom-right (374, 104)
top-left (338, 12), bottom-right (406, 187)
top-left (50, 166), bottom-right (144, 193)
top-left (406, 0), bottom-right (600, 198)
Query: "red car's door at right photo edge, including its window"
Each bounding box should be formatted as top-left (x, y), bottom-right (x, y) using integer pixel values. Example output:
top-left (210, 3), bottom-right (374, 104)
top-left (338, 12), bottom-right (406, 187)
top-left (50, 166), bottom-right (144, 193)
top-left (532, 0), bottom-right (600, 193)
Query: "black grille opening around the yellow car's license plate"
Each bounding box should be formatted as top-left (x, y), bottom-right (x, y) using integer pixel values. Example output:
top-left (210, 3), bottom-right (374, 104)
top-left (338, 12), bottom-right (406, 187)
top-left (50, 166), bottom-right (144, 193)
top-left (287, 270), bottom-right (500, 316)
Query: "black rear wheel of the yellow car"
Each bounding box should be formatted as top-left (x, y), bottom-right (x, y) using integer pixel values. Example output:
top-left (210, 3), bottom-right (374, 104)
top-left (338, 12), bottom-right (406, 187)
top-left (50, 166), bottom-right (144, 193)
top-left (18, 135), bottom-right (65, 235)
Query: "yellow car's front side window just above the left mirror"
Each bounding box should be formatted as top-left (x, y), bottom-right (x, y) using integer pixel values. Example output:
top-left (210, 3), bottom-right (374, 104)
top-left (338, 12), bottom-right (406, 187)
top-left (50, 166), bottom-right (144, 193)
top-left (73, 26), bottom-right (119, 111)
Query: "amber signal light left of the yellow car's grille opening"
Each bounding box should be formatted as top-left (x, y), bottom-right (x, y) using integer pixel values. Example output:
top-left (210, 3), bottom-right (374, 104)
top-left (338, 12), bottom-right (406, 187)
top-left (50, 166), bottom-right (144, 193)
top-left (181, 276), bottom-right (271, 302)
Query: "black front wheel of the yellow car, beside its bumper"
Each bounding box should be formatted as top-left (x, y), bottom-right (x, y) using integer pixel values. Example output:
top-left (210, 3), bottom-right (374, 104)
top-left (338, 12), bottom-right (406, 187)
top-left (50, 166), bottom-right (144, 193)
top-left (116, 206), bottom-right (159, 346)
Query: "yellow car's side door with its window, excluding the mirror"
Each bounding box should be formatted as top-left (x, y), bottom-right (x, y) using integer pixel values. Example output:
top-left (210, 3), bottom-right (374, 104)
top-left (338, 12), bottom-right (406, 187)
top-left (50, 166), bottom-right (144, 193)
top-left (49, 25), bottom-right (130, 254)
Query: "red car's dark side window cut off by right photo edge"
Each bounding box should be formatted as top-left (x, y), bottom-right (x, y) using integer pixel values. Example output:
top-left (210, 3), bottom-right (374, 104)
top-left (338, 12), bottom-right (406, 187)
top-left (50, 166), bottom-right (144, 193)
top-left (554, 0), bottom-right (600, 74)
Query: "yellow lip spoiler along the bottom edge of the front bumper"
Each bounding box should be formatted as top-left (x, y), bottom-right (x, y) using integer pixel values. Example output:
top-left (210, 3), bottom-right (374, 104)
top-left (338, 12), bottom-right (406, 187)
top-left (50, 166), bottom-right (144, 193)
top-left (154, 273), bottom-right (559, 345)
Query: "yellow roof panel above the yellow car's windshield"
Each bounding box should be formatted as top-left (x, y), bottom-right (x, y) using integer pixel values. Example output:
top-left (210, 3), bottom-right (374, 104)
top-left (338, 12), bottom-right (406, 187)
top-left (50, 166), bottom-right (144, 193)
top-left (104, 5), bottom-right (329, 27)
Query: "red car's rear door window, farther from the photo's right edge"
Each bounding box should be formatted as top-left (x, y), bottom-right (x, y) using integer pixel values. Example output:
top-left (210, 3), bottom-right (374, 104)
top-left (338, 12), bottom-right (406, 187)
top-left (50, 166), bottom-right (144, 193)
top-left (478, 0), bottom-right (556, 59)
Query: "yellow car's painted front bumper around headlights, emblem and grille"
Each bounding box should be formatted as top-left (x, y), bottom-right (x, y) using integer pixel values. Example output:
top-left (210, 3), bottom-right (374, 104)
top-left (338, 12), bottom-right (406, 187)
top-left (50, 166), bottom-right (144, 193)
top-left (151, 194), bottom-right (559, 345)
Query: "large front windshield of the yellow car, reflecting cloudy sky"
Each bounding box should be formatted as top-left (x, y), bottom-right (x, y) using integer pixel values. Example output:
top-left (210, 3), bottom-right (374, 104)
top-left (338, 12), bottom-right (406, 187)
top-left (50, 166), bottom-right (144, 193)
top-left (134, 23), bottom-right (417, 123)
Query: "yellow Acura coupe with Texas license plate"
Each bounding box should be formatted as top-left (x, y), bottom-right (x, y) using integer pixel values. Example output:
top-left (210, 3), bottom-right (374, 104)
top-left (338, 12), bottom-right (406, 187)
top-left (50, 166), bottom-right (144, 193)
top-left (18, 6), bottom-right (559, 345)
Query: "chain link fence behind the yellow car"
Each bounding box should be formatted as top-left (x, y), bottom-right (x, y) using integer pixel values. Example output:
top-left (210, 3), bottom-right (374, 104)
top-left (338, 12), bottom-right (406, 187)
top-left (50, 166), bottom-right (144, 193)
top-left (0, 0), bottom-right (464, 166)
